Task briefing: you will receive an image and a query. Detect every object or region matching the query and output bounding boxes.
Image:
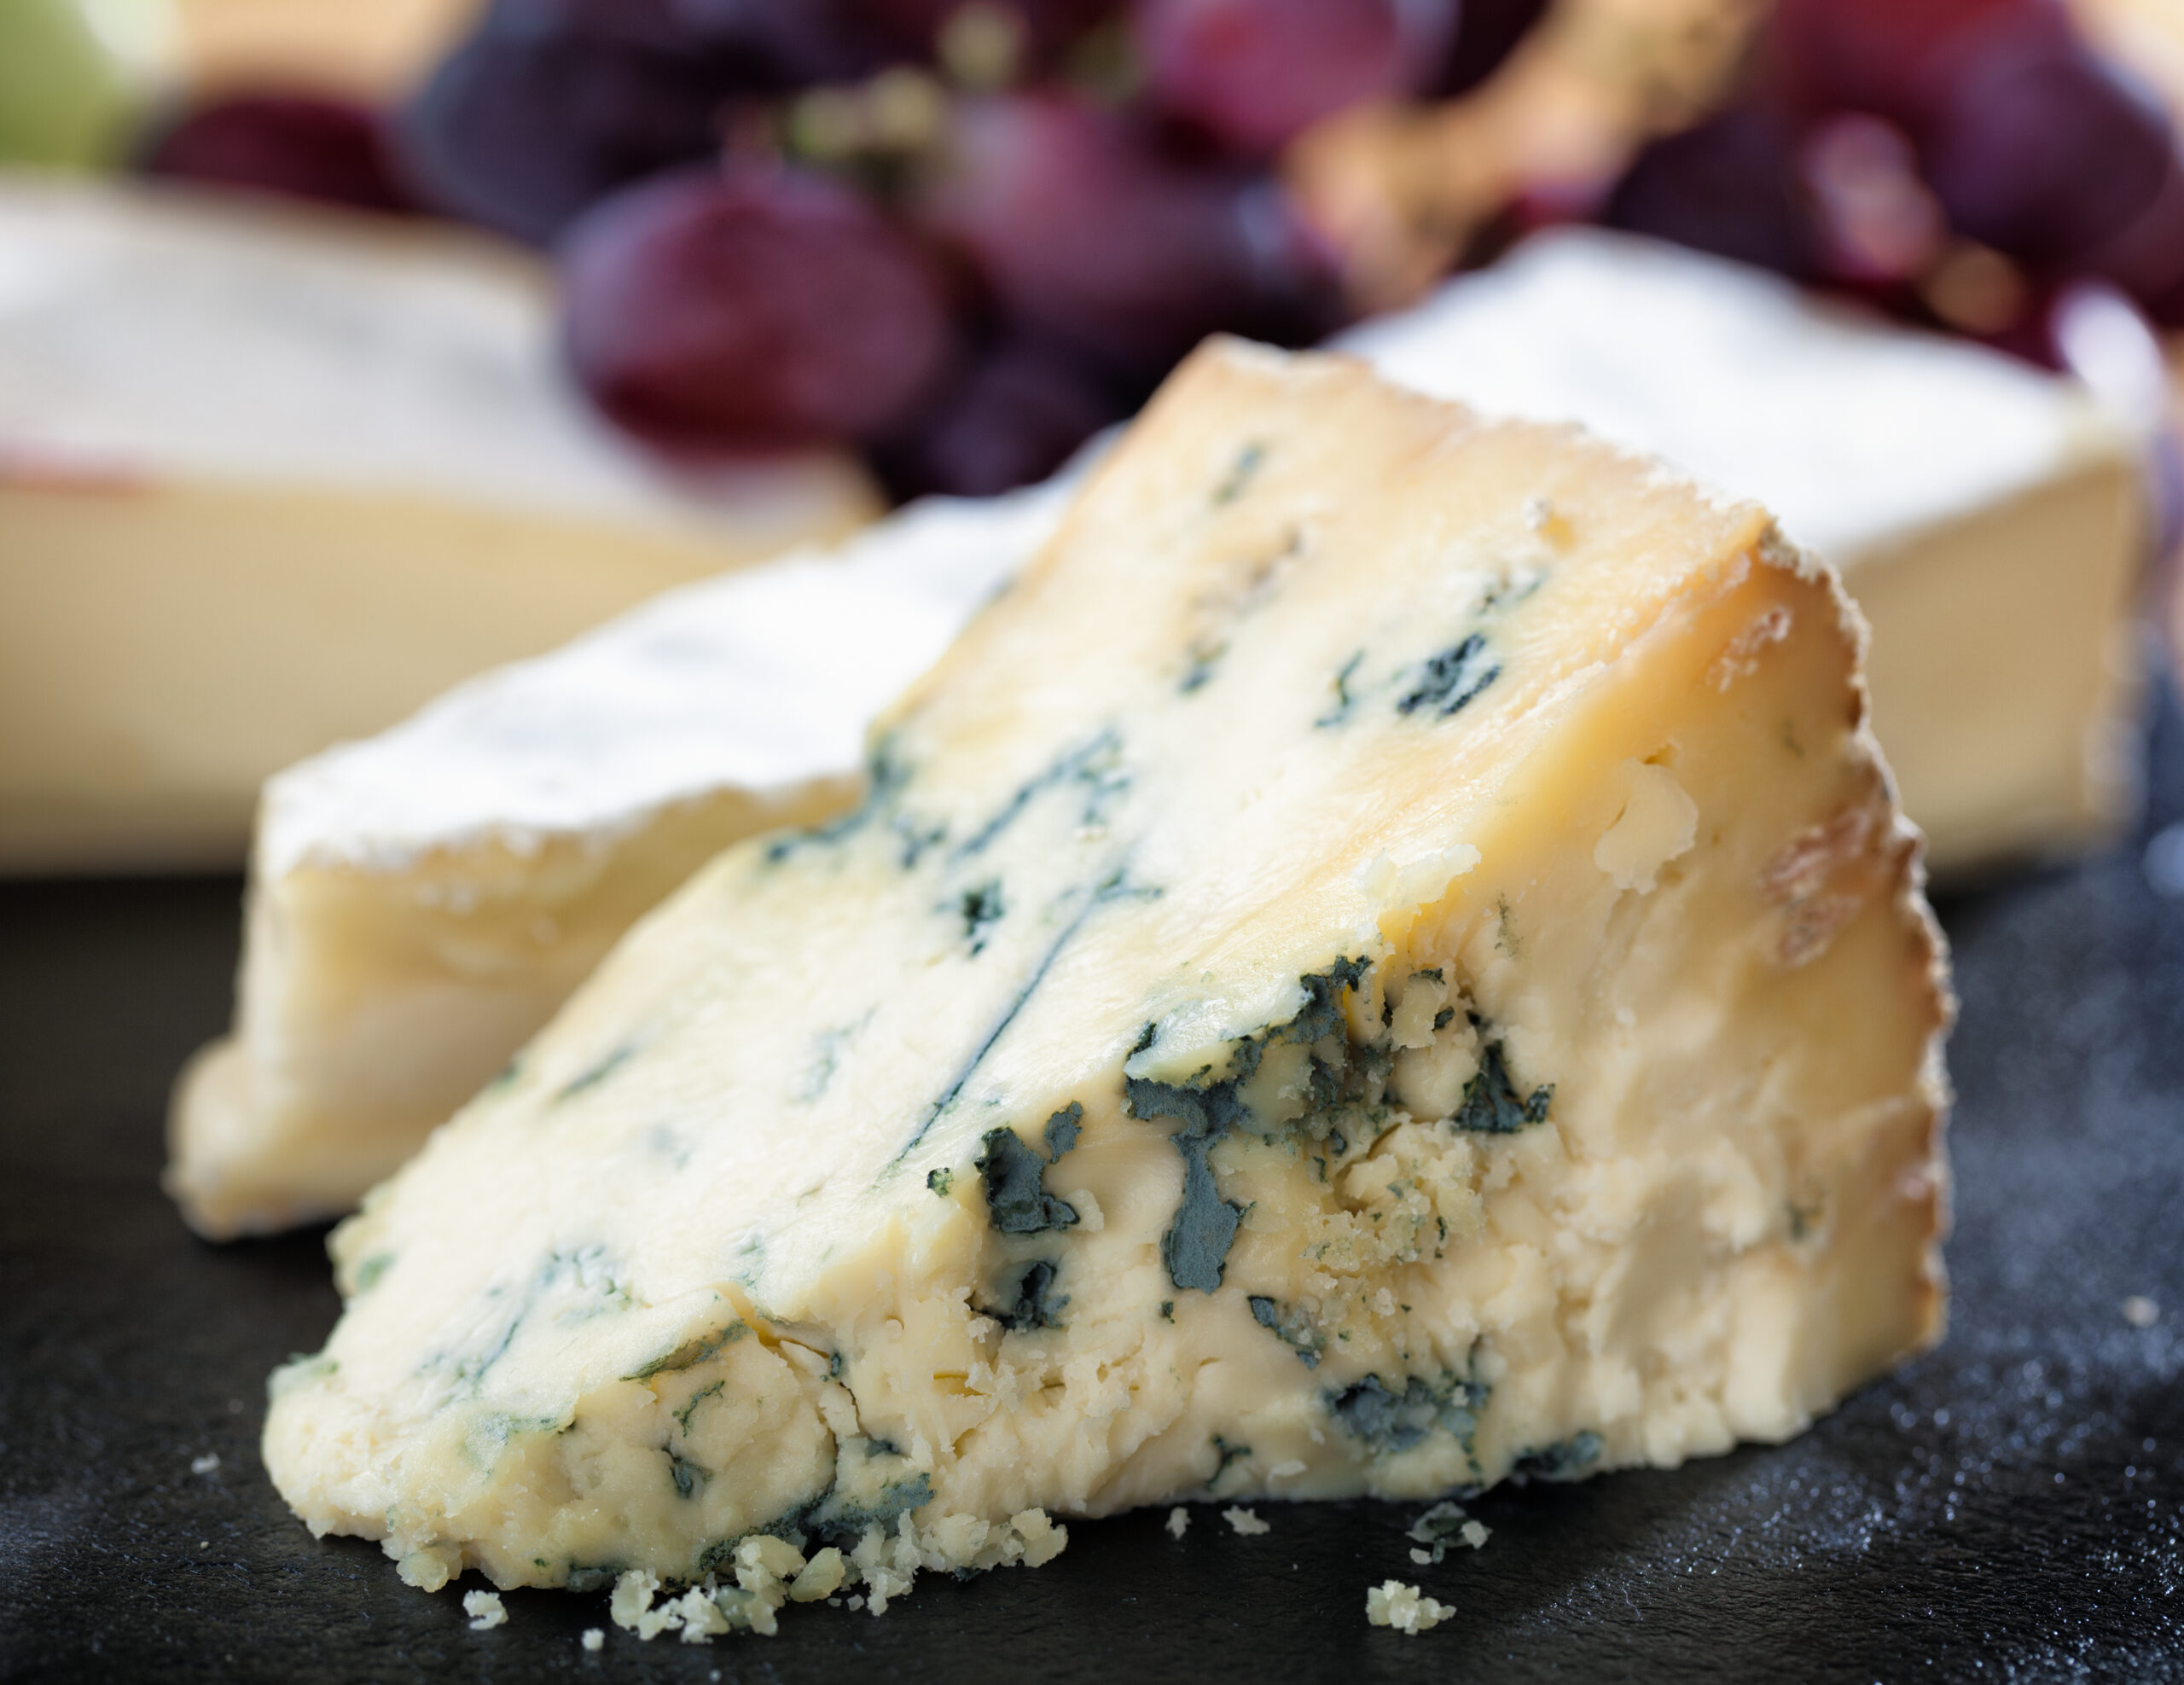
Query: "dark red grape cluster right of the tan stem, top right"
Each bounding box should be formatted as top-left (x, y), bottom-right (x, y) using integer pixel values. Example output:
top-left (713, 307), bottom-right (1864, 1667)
top-left (1603, 0), bottom-right (2184, 363)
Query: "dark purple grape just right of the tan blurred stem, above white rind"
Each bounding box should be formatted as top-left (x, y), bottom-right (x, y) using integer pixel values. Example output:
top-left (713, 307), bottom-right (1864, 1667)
top-left (1600, 105), bottom-right (1821, 277)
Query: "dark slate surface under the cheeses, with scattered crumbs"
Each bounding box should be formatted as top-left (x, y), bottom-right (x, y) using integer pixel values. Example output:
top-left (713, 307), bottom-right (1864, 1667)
top-left (0, 704), bottom-right (2184, 1681)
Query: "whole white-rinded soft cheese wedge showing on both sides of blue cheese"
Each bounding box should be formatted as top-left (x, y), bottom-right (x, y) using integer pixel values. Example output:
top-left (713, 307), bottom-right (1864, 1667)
top-left (171, 232), bottom-right (2079, 1235)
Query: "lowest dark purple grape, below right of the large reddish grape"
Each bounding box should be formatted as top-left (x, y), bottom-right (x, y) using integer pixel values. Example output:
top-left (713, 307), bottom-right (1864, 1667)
top-left (880, 339), bottom-right (1127, 498)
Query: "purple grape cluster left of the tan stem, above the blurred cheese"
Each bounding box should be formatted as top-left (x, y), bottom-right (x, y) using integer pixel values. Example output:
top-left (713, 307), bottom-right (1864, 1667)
top-left (148, 0), bottom-right (1540, 494)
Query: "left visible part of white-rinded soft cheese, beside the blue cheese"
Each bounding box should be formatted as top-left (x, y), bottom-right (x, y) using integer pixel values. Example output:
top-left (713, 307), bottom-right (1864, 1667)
top-left (166, 487), bottom-right (1061, 1237)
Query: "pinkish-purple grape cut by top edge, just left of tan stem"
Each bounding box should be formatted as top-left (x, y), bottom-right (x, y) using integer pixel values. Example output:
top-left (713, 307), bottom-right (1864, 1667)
top-left (1136, 0), bottom-right (1457, 157)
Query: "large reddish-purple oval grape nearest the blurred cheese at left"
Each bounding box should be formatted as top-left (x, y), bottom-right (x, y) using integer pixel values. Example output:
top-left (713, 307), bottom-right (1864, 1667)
top-left (561, 164), bottom-right (955, 450)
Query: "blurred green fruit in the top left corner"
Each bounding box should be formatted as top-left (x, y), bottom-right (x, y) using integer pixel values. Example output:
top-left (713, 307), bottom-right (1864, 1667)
top-left (0, 0), bottom-right (161, 168)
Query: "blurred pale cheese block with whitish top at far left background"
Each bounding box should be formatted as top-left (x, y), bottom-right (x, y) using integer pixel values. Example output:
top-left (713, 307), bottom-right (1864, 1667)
top-left (0, 177), bottom-right (876, 872)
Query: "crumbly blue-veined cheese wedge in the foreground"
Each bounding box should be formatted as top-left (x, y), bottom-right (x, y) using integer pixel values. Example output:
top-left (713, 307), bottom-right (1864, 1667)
top-left (264, 343), bottom-right (1949, 1635)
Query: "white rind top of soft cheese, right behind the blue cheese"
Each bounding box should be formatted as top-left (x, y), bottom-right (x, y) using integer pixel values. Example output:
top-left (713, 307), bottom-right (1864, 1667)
top-left (1339, 230), bottom-right (2134, 559)
